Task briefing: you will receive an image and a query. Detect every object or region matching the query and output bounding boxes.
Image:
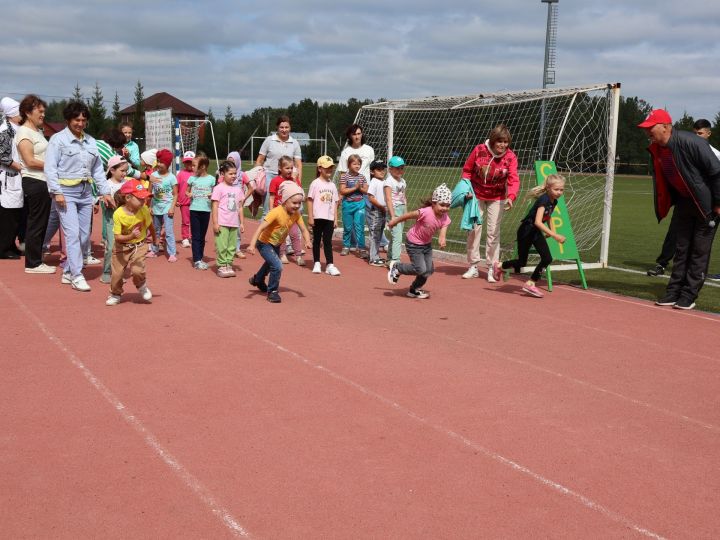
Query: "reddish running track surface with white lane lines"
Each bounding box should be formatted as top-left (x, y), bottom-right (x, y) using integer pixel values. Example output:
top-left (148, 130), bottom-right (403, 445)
top-left (0, 217), bottom-right (720, 539)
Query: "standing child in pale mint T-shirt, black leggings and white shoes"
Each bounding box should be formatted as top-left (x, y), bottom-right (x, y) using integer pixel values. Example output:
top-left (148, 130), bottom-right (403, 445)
top-left (186, 155), bottom-right (215, 270)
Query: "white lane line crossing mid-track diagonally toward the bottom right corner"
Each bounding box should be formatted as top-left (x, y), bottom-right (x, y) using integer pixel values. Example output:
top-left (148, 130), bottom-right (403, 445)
top-left (169, 292), bottom-right (664, 540)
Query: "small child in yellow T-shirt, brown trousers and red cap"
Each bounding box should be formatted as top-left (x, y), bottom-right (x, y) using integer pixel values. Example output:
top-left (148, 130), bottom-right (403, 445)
top-left (105, 180), bottom-right (157, 306)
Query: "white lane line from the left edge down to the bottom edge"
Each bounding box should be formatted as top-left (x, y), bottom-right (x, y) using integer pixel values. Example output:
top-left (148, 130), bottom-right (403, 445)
top-left (0, 281), bottom-right (250, 538)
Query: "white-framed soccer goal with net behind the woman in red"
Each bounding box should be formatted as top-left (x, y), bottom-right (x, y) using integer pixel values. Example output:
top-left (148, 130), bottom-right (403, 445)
top-left (356, 83), bottom-right (620, 269)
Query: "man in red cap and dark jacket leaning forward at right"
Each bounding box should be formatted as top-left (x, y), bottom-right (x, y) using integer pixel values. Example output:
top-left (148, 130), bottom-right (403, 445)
top-left (638, 109), bottom-right (720, 309)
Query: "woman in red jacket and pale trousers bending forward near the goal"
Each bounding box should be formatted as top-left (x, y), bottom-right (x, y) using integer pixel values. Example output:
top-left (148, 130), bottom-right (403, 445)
top-left (462, 124), bottom-right (520, 283)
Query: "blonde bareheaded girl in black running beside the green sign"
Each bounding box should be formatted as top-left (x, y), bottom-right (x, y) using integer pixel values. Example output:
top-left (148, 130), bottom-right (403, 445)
top-left (493, 174), bottom-right (565, 298)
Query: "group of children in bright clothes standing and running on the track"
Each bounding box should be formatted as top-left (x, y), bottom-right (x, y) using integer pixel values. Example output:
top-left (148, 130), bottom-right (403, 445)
top-left (98, 150), bottom-right (565, 305)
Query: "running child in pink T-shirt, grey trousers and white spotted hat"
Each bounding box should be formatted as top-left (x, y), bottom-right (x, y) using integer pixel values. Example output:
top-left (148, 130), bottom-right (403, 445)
top-left (388, 184), bottom-right (452, 298)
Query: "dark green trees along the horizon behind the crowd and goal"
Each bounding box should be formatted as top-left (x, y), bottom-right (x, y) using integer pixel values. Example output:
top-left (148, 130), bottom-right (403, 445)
top-left (40, 81), bottom-right (720, 174)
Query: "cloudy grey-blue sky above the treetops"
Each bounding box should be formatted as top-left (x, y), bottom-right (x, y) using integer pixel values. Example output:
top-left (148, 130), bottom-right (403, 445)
top-left (0, 0), bottom-right (720, 119)
